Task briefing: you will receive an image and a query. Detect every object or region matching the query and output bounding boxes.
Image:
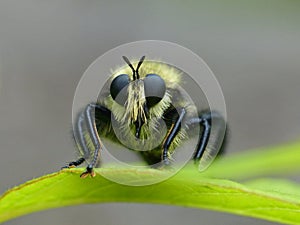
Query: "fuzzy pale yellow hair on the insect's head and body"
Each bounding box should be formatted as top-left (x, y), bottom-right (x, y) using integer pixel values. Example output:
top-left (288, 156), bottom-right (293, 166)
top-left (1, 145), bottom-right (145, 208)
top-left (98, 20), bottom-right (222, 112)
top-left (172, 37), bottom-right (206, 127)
top-left (88, 60), bottom-right (192, 161)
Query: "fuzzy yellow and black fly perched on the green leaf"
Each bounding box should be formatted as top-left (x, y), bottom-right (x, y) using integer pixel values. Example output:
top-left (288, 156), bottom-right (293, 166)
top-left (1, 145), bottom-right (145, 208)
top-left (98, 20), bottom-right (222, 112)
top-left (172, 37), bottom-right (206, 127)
top-left (68, 56), bottom-right (225, 177)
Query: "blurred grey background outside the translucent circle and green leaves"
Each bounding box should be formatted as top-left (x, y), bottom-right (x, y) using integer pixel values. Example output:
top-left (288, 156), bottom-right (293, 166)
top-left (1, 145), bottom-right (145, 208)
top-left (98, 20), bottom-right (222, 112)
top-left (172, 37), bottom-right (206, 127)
top-left (0, 0), bottom-right (300, 225)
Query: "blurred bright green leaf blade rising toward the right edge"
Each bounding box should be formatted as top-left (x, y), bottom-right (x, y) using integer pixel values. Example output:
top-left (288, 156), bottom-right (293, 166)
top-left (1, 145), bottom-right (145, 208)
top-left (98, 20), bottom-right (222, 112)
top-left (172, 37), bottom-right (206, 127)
top-left (202, 142), bottom-right (300, 180)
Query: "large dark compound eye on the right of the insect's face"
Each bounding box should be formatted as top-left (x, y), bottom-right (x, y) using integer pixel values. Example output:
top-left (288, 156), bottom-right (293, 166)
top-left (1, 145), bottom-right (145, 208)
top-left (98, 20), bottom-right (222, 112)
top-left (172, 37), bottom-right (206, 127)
top-left (144, 74), bottom-right (166, 107)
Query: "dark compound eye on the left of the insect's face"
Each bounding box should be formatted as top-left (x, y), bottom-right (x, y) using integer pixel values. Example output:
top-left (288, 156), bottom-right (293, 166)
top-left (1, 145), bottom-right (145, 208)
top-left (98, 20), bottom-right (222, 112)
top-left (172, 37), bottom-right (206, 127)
top-left (110, 74), bottom-right (130, 105)
